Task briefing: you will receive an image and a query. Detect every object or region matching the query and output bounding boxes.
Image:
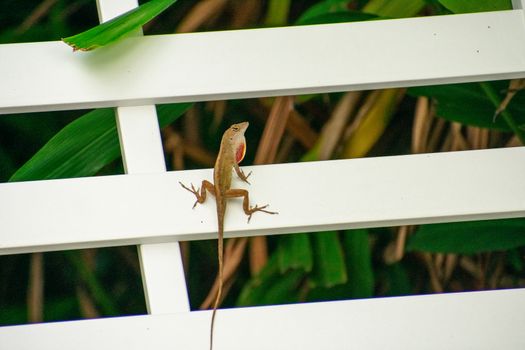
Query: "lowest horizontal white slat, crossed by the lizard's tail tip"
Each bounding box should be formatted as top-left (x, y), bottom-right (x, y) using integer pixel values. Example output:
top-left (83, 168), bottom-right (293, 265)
top-left (0, 289), bottom-right (525, 350)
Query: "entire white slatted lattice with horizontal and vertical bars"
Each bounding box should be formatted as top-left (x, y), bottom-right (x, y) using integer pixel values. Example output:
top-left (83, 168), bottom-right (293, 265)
top-left (0, 0), bottom-right (525, 350)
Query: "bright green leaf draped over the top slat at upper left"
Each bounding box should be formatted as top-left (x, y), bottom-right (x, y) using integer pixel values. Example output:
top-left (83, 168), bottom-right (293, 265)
top-left (62, 0), bottom-right (177, 51)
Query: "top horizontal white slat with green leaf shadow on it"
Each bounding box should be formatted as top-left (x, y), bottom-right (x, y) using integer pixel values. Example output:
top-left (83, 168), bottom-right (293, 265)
top-left (0, 10), bottom-right (525, 113)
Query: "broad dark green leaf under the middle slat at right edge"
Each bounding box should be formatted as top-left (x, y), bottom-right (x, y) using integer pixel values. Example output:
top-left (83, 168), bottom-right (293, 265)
top-left (407, 218), bottom-right (525, 254)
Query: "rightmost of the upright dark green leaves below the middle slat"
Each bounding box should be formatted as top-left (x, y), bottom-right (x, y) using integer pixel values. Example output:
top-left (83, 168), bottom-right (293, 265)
top-left (343, 229), bottom-right (374, 298)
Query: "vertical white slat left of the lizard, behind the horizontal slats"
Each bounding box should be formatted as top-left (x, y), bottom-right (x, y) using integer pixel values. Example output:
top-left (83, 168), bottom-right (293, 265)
top-left (97, 0), bottom-right (190, 314)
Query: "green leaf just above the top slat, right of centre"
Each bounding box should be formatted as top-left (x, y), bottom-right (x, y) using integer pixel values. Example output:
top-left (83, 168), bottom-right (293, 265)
top-left (295, 0), bottom-right (378, 25)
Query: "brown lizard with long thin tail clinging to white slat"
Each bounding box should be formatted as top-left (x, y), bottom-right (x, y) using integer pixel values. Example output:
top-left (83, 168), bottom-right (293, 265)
top-left (179, 122), bottom-right (277, 350)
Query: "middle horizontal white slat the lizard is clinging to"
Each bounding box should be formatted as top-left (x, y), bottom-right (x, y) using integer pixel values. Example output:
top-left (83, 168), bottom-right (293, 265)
top-left (0, 147), bottom-right (525, 254)
